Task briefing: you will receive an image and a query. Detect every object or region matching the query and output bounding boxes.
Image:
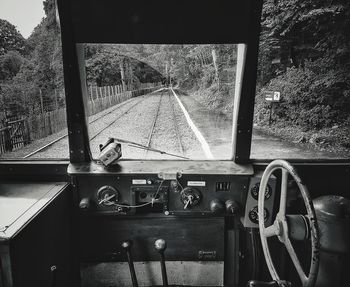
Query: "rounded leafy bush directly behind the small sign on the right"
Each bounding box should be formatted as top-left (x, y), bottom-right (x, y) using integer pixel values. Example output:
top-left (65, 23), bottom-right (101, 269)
top-left (255, 59), bottom-right (350, 129)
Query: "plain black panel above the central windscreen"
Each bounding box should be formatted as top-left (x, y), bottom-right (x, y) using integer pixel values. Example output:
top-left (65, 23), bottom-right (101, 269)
top-left (58, 0), bottom-right (262, 44)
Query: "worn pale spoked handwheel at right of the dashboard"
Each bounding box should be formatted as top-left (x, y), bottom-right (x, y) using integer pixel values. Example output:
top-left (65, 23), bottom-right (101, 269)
top-left (258, 160), bottom-right (320, 287)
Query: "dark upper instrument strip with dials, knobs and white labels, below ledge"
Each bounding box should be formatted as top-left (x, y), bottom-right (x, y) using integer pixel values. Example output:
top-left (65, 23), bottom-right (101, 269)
top-left (78, 174), bottom-right (249, 216)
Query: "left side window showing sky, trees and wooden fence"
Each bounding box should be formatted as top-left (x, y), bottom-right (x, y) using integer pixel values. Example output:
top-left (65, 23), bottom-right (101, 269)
top-left (0, 0), bottom-right (69, 159)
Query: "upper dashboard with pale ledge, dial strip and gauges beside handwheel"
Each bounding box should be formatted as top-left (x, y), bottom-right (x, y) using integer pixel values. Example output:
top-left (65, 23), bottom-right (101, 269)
top-left (68, 161), bottom-right (275, 223)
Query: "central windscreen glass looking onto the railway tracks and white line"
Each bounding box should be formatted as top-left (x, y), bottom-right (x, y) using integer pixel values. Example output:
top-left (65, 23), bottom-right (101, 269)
top-left (85, 44), bottom-right (237, 159)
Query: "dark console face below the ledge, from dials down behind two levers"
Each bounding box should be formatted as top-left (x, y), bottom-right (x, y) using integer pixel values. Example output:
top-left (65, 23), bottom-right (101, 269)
top-left (74, 173), bottom-right (246, 262)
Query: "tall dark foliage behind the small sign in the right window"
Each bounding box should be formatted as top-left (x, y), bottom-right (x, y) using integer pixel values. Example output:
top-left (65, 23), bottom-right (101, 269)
top-left (256, 0), bottom-right (350, 133)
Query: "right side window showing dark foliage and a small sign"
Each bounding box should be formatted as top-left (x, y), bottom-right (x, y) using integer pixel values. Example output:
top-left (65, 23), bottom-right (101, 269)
top-left (251, 0), bottom-right (350, 159)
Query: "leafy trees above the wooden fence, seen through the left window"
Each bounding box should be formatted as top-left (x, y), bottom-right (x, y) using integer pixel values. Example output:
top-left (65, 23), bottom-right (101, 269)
top-left (0, 0), bottom-right (64, 118)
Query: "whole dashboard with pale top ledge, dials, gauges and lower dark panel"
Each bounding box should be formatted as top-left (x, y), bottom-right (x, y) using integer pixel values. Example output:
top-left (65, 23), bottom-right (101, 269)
top-left (68, 161), bottom-right (275, 276)
